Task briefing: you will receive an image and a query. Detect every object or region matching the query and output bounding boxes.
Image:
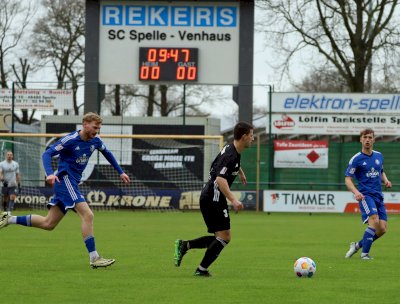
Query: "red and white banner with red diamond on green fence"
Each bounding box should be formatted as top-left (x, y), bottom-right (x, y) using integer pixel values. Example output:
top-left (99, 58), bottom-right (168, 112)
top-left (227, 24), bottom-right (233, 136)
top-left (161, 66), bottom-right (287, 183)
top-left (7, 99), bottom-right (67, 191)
top-left (274, 140), bottom-right (328, 169)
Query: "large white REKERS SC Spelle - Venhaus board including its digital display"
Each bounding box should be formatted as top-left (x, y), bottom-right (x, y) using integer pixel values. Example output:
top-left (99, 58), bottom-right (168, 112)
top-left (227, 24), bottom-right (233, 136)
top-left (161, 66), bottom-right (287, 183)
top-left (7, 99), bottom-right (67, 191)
top-left (99, 0), bottom-right (240, 85)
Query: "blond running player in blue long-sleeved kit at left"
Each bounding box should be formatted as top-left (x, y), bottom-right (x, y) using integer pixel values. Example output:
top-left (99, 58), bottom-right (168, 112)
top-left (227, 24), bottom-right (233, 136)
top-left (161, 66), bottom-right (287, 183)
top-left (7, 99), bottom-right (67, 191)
top-left (0, 113), bottom-right (130, 268)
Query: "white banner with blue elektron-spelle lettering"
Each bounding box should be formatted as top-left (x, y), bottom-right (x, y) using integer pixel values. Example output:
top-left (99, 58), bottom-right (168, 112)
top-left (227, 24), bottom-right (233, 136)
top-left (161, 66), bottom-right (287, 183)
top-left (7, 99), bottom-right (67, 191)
top-left (271, 92), bottom-right (400, 114)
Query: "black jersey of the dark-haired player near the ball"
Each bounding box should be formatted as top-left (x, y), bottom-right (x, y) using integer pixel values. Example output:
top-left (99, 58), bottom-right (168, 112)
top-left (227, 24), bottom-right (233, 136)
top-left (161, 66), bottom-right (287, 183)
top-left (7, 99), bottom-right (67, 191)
top-left (203, 144), bottom-right (240, 194)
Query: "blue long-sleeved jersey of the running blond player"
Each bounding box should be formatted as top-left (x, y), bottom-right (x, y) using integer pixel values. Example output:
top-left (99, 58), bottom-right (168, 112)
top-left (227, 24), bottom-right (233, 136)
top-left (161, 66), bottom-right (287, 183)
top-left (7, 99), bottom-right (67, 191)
top-left (42, 131), bottom-right (123, 182)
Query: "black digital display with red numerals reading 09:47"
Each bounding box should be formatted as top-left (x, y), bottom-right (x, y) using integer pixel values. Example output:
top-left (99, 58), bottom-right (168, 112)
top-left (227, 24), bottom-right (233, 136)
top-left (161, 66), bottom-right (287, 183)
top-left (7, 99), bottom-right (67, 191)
top-left (139, 47), bottom-right (199, 82)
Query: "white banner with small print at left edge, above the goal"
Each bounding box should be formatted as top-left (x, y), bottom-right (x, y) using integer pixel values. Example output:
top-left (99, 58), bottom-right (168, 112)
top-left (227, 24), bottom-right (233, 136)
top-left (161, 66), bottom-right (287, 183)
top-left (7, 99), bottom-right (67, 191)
top-left (0, 89), bottom-right (73, 110)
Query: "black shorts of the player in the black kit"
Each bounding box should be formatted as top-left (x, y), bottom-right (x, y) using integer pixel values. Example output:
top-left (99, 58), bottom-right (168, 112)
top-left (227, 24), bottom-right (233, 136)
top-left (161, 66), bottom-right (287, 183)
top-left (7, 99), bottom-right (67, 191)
top-left (200, 193), bottom-right (231, 233)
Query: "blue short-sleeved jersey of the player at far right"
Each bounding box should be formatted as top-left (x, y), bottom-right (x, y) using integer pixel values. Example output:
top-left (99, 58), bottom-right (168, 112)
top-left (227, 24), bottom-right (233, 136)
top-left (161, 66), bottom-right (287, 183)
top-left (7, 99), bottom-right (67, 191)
top-left (345, 151), bottom-right (383, 200)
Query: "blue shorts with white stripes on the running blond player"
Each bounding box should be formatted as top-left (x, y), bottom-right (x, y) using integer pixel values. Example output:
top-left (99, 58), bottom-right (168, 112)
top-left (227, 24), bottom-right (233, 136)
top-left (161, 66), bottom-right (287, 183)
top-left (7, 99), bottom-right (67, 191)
top-left (48, 175), bottom-right (86, 214)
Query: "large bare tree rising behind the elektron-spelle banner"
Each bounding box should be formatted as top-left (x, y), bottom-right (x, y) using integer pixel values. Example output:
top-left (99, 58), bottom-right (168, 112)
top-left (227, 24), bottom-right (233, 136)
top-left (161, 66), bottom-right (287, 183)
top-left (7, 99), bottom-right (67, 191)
top-left (256, 0), bottom-right (400, 92)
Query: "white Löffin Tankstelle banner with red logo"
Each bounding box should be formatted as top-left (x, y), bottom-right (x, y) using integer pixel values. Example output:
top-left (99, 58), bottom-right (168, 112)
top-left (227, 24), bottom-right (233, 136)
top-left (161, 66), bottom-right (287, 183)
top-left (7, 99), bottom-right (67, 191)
top-left (267, 113), bottom-right (400, 135)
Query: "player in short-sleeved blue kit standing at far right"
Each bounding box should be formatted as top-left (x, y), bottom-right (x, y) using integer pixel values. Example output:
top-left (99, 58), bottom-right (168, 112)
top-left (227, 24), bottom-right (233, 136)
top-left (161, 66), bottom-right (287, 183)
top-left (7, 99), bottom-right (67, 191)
top-left (345, 128), bottom-right (392, 260)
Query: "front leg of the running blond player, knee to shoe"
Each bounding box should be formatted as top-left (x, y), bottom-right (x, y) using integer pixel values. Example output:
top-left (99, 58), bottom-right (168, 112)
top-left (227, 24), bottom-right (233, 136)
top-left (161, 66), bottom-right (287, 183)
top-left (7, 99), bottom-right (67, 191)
top-left (75, 202), bottom-right (115, 268)
